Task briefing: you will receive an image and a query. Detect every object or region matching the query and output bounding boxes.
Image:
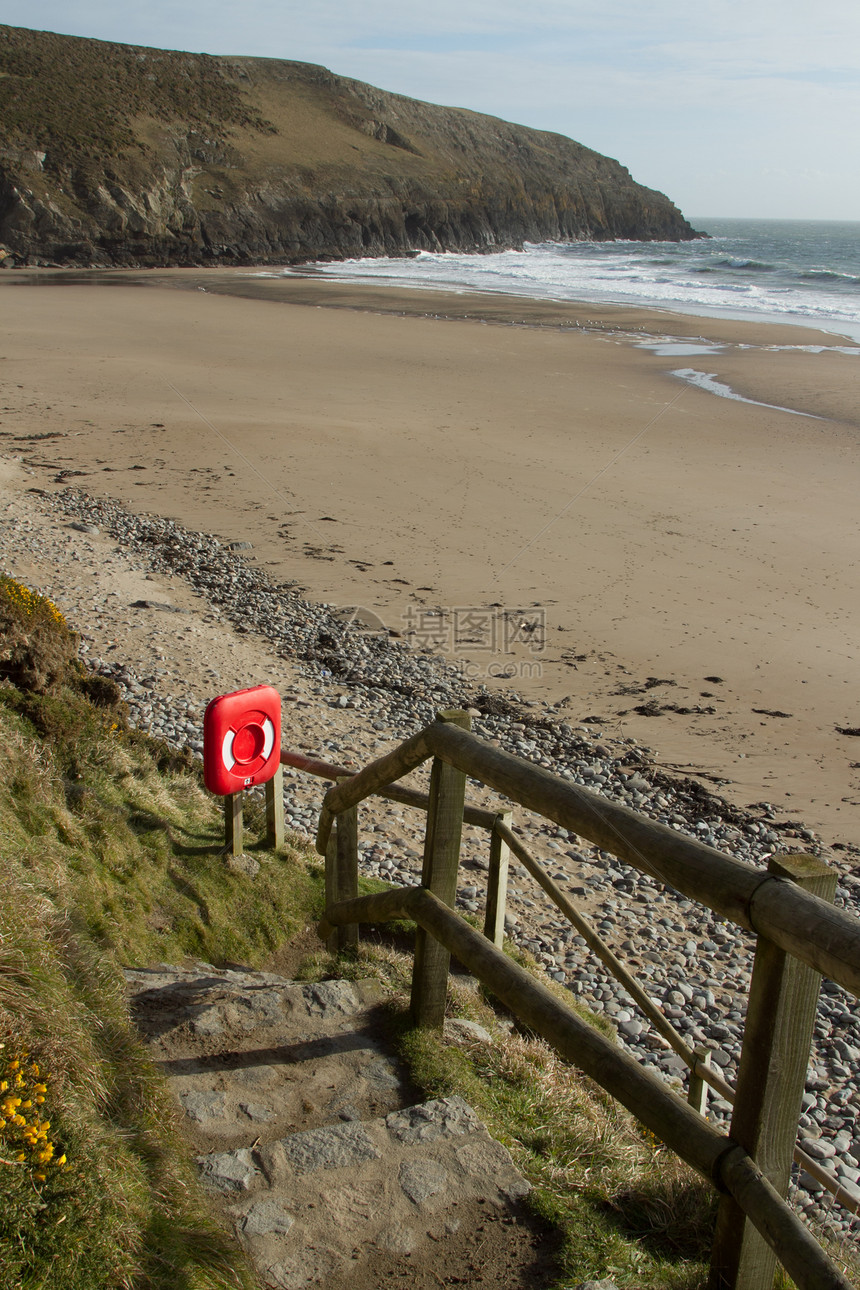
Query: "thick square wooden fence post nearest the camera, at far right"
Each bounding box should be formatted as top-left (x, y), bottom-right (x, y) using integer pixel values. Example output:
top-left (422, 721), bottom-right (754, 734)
top-left (708, 855), bottom-right (837, 1290)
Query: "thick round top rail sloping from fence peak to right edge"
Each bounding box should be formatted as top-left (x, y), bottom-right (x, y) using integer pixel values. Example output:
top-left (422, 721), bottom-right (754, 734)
top-left (425, 722), bottom-right (860, 995)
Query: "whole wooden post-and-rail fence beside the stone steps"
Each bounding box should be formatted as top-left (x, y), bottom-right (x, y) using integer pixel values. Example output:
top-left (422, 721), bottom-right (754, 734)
top-left (282, 712), bottom-right (860, 1290)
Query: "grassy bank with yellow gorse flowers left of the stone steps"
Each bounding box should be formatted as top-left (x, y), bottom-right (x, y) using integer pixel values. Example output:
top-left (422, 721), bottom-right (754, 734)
top-left (0, 579), bottom-right (322, 1290)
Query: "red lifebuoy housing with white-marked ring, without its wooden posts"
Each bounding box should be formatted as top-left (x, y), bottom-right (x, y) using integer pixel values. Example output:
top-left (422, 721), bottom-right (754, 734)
top-left (204, 685), bottom-right (281, 797)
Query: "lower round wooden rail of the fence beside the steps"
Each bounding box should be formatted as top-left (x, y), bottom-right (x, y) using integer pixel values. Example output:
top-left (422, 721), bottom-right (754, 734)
top-left (320, 888), bottom-right (851, 1290)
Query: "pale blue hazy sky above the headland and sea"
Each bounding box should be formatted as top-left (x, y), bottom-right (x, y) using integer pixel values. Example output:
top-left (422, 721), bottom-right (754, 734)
top-left (0, 0), bottom-right (860, 223)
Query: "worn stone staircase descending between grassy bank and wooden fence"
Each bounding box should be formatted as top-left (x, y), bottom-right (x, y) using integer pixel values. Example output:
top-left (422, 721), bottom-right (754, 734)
top-left (126, 964), bottom-right (554, 1290)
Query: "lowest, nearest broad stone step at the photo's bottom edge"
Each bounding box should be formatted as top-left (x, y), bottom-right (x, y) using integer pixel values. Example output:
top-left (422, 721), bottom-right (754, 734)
top-left (208, 1098), bottom-right (529, 1290)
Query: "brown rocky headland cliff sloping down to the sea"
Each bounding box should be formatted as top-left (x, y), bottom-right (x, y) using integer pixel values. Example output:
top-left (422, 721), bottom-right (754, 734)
top-left (0, 27), bottom-right (696, 266)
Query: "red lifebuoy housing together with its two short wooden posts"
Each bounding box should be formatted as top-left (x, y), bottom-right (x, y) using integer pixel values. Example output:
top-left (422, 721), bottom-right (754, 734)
top-left (202, 685), bottom-right (284, 855)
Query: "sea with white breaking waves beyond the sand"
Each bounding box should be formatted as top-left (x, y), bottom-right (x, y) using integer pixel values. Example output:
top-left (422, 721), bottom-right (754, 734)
top-left (275, 217), bottom-right (860, 342)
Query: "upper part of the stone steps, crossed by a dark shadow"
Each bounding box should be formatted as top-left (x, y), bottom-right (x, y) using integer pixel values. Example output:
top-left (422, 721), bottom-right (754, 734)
top-left (126, 968), bottom-right (410, 1151)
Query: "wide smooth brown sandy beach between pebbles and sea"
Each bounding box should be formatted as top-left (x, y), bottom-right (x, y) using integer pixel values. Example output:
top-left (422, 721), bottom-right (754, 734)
top-left (0, 270), bottom-right (860, 845)
